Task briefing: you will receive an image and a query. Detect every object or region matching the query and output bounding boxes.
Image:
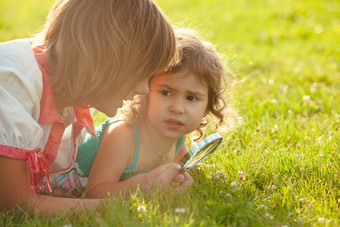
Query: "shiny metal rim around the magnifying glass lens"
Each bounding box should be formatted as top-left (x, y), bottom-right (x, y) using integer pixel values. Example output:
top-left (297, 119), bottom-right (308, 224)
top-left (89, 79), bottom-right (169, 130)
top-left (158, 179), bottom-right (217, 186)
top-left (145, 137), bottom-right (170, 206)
top-left (179, 132), bottom-right (223, 171)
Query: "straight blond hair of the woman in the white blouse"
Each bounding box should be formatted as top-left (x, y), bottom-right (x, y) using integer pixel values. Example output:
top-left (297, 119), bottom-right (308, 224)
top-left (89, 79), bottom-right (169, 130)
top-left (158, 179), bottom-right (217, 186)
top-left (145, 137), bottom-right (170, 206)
top-left (33, 0), bottom-right (175, 106)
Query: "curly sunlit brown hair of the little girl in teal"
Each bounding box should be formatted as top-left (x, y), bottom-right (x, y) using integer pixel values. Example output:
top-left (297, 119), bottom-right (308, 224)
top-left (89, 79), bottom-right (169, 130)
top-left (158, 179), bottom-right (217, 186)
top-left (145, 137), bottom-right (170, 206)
top-left (122, 28), bottom-right (238, 139)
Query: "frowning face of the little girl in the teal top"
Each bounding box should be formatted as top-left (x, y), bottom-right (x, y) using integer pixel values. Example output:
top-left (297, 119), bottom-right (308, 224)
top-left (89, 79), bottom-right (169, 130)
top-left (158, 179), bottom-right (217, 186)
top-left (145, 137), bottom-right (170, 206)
top-left (148, 70), bottom-right (208, 138)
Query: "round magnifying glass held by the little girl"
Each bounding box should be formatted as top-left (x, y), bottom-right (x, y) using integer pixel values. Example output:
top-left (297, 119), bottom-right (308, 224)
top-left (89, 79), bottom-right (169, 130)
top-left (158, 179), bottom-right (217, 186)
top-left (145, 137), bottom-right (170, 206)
top-left (179, 132), bottom-right (223, 171)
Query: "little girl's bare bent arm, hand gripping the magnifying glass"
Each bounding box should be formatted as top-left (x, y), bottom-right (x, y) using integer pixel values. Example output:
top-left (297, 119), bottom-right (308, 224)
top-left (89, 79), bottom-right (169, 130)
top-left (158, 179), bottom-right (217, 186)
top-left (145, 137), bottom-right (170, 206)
top-left (86, 122), bottom-right (184, 198)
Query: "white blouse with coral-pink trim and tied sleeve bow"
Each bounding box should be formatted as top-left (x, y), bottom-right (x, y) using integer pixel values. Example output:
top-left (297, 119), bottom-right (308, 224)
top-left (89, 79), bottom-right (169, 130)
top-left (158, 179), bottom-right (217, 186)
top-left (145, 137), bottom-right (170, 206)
top-left (0, 39), bottom-right (94, 191)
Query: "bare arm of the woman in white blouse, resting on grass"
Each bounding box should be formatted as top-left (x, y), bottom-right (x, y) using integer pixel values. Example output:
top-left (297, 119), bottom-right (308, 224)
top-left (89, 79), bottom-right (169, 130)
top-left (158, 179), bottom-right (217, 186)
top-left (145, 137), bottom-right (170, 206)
top-left (0, 156), bottom-right (100, 215)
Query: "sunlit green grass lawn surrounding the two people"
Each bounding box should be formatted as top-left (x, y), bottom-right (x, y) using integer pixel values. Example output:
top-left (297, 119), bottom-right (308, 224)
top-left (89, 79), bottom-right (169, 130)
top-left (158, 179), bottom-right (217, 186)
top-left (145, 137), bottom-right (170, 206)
top-left (0, 0), bottom-right (340, 226)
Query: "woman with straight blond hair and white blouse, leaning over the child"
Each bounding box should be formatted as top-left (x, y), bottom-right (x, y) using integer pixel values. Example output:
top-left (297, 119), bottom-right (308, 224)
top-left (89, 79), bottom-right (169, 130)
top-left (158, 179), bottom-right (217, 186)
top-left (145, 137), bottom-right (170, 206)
top-left (0, 0), bottom-right (180, 214)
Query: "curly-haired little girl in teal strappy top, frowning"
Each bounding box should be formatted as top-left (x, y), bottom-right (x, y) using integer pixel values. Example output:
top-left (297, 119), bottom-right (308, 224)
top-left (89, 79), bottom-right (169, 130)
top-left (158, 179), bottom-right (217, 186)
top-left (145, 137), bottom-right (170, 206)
top-left (65, 30), bottom-right (236, 198)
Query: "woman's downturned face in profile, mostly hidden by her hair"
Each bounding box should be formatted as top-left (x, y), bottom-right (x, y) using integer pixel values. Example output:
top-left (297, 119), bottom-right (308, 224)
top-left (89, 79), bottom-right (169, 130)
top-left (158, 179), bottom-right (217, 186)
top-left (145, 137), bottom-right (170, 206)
top-left (93, 79), bottom-right (149, 117)
